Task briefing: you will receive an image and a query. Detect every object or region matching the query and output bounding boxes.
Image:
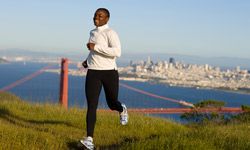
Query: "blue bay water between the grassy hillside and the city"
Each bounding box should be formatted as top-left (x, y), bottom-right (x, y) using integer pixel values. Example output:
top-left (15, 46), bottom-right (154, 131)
top-left (0, 62), bottom-right (250, 119)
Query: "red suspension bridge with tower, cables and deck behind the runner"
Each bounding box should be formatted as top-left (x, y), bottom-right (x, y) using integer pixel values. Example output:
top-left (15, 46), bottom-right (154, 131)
top-left (0, 59), bottom-right (243, 114)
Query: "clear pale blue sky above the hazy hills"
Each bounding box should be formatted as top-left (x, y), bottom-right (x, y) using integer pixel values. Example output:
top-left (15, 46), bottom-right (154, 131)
top-left (0, 0), bottom-right (250, 58)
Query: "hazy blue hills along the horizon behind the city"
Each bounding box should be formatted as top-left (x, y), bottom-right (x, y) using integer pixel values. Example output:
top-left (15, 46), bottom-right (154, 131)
top-left (0, 48), bottom-right (250, 70)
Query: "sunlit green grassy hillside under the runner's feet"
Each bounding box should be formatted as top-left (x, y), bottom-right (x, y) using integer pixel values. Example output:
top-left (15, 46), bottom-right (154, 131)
top-left (0, 93), bottom-right (250, 150)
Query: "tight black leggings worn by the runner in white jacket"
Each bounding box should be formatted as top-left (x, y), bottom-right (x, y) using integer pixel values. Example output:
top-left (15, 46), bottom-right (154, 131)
top-left (85, 69), bottom-right (123, 137)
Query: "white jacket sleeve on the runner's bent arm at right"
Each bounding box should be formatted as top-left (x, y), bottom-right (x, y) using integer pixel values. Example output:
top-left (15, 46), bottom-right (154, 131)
top-left (94, 31), bottom-right (121, 57)
